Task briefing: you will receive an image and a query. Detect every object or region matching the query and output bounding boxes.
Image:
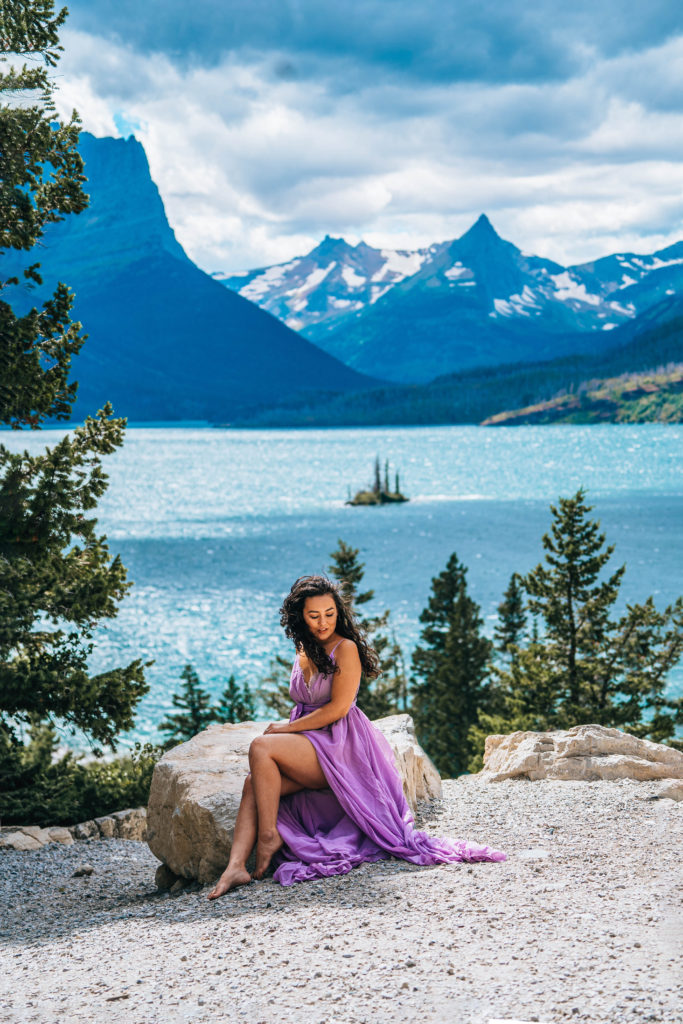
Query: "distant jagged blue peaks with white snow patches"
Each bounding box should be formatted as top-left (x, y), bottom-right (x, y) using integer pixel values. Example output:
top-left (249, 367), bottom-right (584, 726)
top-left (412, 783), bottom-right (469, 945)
top-left (220, 214), bottom-right (683, 383)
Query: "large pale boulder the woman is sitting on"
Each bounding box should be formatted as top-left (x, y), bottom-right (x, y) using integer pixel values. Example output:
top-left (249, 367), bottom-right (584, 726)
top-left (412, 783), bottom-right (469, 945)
top-left (147, 715), bottom-right (441, 888)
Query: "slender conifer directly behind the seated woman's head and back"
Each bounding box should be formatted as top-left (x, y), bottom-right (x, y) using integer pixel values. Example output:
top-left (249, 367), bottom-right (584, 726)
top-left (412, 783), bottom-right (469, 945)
top-left (330, 540), bottom-right (408, 719)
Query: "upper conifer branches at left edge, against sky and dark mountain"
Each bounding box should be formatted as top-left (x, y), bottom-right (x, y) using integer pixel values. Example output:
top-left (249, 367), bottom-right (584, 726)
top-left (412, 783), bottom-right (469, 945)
top-left (0, 0), bottom-right (88, 427)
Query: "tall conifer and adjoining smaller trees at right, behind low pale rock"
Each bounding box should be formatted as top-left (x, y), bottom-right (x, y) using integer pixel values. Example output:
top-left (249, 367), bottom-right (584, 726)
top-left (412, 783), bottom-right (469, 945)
top-left (472, 489), bottom-right (683, 761)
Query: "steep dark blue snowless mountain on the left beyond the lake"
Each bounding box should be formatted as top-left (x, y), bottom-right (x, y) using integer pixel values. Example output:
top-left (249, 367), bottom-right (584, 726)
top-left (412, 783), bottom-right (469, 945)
top-left (1, 132), bottom-right (377, 422)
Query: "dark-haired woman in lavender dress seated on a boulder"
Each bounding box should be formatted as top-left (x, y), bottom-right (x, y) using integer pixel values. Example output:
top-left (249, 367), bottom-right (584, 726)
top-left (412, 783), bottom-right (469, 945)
top-left (209, 575), bottom-right (505, 899)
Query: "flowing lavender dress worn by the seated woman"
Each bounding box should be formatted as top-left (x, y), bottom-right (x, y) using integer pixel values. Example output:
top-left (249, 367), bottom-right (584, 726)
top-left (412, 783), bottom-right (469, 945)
top-left (273, 650), bottom-right (506, 886)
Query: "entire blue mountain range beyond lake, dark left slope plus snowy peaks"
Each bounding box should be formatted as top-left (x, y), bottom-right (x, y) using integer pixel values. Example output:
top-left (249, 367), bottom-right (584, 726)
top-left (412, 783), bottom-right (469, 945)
top-left (0, 132), bottom-right (683, 425)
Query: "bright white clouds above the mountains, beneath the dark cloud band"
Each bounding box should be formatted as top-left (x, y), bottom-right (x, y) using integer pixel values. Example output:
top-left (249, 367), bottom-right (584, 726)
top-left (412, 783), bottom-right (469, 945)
top-left (54, 31), bottom-right (683, 271)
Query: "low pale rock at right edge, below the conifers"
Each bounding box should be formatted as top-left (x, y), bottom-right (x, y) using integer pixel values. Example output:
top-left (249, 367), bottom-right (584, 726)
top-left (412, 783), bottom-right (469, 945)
top-left (479, 725), bottom-right (683, 782)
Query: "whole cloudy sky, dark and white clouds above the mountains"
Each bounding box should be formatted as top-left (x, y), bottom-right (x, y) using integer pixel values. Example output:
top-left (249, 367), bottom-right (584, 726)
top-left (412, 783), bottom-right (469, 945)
top-left (58, 0), bottom-right (683, 271)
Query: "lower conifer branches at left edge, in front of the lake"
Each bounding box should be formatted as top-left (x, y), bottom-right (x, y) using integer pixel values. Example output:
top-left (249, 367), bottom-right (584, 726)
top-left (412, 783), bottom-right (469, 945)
top-left (0, 408), bottom-right (146, 744)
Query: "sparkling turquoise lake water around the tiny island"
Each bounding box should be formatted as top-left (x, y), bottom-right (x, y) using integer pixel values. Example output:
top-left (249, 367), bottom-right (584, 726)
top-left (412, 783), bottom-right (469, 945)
top-left (2, 424), bottom-right (683, 742)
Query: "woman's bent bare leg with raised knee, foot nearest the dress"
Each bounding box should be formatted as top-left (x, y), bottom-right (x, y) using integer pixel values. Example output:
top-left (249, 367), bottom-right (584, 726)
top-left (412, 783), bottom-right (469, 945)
top-left (249, 733), bottom-right (328, 879)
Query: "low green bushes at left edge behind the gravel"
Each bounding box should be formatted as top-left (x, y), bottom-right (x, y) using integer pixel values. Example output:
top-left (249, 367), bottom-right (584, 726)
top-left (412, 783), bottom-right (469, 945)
top-left (0, 720), bottom-right (162, 825)
